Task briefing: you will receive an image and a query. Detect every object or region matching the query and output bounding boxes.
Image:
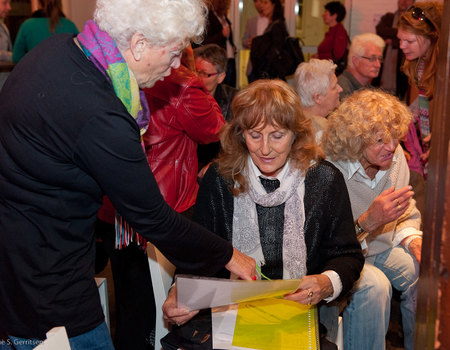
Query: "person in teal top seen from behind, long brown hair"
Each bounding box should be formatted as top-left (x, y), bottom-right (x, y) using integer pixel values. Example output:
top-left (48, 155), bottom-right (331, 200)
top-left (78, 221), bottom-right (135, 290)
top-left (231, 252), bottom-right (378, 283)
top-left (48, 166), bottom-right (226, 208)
top-left (13, 0), bottom-right (78, 62)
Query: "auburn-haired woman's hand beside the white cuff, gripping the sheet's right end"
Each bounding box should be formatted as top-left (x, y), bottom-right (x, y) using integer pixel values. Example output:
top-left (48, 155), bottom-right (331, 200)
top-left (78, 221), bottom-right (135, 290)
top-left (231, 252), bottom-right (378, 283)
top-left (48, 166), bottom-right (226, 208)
top-left (284, 275), bottom-right (334, 305)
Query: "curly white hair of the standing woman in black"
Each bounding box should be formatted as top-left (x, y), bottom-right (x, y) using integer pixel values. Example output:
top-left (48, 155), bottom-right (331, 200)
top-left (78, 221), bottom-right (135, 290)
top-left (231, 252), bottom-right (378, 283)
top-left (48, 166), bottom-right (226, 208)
top-left (94, 0), bottom-right (207, 50)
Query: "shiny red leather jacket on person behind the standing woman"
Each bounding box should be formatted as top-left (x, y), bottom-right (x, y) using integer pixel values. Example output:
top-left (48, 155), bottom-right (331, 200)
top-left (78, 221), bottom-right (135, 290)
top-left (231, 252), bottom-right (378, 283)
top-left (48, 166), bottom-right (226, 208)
top-left (143, 48), bottom-right (225, 214)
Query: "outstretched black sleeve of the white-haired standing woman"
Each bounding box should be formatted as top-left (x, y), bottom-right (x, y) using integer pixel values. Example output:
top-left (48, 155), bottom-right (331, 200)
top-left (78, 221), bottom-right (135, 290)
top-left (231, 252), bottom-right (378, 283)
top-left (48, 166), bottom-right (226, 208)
top-left (74, 110), bottom-right (233, 275)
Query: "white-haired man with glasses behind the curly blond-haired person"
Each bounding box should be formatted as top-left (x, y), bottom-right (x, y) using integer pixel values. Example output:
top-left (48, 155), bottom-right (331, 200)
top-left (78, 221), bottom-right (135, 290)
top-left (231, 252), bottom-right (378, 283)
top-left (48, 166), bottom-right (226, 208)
top-left (338, 33), bottom-right (385, 101)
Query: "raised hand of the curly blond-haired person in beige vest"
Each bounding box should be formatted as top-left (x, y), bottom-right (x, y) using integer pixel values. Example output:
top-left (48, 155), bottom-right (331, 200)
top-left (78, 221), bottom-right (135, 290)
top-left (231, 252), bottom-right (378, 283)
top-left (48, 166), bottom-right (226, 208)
top-left (358, 186), bottom-right (414, 232)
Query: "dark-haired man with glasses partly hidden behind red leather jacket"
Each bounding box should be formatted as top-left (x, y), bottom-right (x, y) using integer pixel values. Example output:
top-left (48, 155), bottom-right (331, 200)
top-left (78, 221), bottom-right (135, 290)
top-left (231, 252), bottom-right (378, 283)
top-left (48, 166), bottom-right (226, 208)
top-left (194, 44), bottom-right (238, 172)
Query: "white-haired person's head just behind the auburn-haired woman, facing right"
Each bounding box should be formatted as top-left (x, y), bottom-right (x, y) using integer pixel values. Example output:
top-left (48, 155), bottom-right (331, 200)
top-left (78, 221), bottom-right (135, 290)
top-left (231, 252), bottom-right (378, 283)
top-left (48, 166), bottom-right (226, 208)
top-left (294, 58), bottom-right (342, 140)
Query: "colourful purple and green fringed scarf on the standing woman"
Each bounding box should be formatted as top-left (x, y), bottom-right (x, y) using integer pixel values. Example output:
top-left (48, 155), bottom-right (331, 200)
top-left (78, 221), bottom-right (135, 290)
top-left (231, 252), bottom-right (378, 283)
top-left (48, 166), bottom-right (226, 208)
top-left (77, 20), bottom-right (150, 249)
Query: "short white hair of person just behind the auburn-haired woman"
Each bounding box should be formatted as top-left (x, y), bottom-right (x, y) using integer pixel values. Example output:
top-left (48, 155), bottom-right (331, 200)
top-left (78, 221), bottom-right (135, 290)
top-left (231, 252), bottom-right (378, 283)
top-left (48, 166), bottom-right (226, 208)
top-left (294, 58), bottom-right (337, 108)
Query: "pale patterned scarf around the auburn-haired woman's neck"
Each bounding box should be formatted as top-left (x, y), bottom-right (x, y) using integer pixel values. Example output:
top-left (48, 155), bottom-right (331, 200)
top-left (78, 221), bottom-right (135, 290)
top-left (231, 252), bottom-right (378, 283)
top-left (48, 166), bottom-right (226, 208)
top-left (232, 156), bottom-right (306, 279)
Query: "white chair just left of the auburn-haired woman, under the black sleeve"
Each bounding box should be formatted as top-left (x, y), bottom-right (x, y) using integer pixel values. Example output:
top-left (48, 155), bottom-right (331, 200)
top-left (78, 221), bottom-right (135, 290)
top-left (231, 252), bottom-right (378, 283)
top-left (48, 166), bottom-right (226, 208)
top-left (147, 243), bottom-right (175, 350)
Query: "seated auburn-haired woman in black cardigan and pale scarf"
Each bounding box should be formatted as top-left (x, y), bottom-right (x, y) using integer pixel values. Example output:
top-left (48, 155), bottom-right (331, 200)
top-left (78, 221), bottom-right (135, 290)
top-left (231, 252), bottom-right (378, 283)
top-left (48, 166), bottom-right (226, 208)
top-left (163, 79), bottom-right (364, 350)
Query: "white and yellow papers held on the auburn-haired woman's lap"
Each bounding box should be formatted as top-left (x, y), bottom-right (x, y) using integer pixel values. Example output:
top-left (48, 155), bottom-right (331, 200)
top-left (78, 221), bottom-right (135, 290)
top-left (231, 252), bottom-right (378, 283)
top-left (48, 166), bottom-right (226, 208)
top-left (176, 275), bottom-right (319, 350)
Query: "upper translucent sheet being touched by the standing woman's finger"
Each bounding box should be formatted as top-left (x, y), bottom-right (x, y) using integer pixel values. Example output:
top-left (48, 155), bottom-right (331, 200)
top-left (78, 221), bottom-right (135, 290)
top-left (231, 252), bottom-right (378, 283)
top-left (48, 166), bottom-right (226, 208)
top-left (175, 275), bottom-right (302, 310)
